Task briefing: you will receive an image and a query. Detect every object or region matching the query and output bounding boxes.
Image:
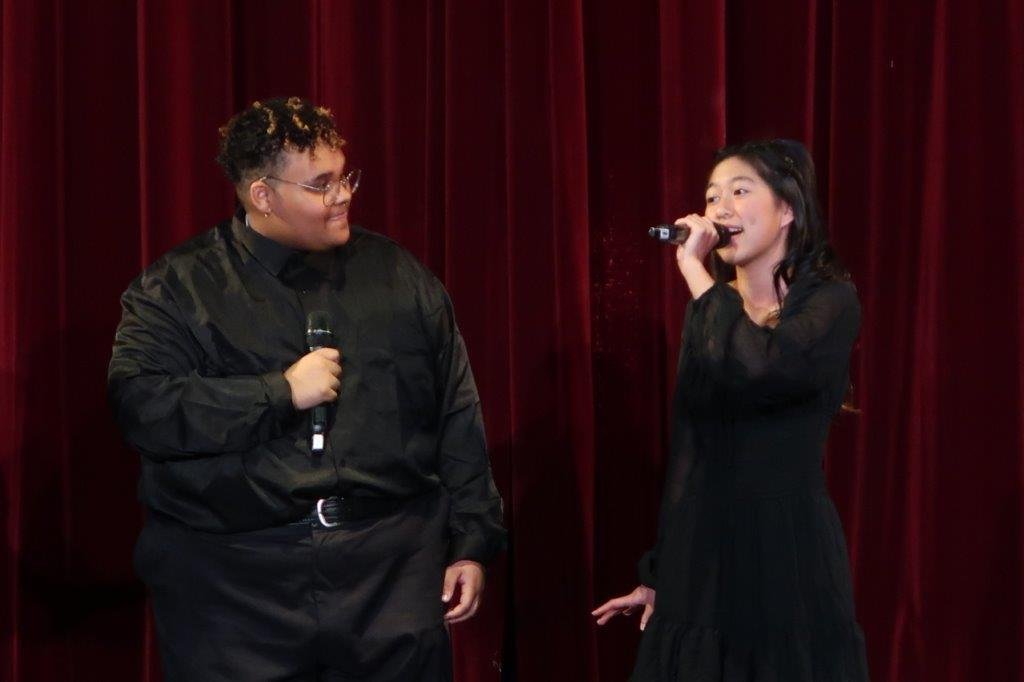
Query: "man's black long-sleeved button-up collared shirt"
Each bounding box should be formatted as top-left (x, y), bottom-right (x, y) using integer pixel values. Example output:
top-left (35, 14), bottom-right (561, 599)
top-left (109, 213), bottom-right (505, 561)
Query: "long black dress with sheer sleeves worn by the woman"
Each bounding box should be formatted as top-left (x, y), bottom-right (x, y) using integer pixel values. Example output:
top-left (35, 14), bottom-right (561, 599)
top-left (632, 276), bottom-right (867, 682)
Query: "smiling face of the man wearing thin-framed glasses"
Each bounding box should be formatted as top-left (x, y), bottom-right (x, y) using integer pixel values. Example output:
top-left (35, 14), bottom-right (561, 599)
top-left (264, 144), bottom-right (352, 251)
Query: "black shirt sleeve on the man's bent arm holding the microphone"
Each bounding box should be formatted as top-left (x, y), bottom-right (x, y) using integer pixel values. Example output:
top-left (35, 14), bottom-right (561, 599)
top-left (108, 270), bottom-right (293, 462)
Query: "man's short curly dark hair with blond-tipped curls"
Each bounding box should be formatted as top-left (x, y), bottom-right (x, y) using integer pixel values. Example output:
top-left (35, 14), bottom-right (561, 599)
top-left (217, 97), bottom-right (345, 184)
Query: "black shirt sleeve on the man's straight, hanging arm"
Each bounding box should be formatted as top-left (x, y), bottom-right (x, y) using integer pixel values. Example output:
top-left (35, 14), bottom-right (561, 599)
top-left (417, 275), bottom-right (506, 564)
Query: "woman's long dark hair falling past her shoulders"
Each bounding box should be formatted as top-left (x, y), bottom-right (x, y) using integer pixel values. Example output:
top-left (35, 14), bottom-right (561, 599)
top-left (712, 139), bottom-right (850, 303)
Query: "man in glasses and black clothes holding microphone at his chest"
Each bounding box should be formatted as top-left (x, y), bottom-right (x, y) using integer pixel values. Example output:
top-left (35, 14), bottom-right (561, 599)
top-left (109, 97), bottom-right (505, 681)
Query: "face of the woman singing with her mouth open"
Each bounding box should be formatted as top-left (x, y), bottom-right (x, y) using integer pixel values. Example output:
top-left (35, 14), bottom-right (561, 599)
top-left (705, 157), bottom-right (793, 267)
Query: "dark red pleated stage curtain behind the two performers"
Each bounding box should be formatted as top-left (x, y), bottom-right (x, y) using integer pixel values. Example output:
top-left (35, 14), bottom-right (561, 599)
top-left (0, 0), bottom-right (1024, 682)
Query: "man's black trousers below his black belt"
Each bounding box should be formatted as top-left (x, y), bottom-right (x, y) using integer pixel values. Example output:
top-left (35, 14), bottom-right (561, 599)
top-left (135, 494), bottom-right (452, 682)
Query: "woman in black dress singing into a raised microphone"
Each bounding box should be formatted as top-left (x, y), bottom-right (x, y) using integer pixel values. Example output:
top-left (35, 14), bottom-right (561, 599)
top-left (593, 140), bottom-right (867, 682)
